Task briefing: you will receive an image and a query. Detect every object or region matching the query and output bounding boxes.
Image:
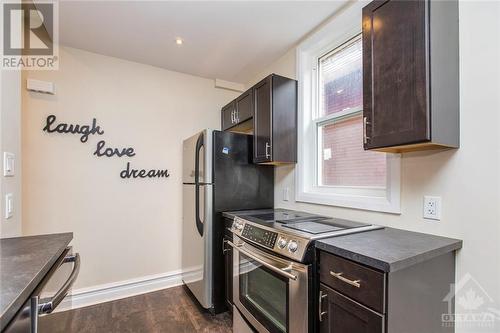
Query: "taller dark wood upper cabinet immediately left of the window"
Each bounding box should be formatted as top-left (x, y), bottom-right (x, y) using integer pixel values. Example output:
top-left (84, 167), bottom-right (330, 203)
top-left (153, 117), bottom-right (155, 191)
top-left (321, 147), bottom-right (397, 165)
top-left (253, 74), bottom-right (297, 165)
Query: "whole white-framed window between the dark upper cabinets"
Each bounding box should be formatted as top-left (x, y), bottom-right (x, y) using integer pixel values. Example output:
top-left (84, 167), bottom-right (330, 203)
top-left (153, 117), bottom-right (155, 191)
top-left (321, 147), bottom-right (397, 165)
top-left (296, 4), bottom-right (400, 213)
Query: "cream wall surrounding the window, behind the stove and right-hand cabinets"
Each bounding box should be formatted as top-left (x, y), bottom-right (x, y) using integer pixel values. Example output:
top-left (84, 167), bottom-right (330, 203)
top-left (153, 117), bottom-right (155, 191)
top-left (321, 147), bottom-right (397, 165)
top-left (249, 1), bottom-right (500, 322)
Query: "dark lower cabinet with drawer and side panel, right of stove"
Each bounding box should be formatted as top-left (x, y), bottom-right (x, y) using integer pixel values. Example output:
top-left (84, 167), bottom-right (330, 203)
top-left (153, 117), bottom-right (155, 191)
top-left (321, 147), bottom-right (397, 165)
top-left (316, 249), bottom-right (455, 333)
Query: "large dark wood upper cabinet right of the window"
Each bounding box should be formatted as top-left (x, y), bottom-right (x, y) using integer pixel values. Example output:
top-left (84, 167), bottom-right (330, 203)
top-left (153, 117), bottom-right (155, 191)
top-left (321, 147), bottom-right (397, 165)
top-left (363, 0), bottom-right (459, 152)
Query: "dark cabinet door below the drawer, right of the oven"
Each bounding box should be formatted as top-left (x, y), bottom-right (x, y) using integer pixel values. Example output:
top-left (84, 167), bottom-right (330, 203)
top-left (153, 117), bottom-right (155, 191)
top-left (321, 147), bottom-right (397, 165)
top-left (319, 284), bottom-right (384, 333)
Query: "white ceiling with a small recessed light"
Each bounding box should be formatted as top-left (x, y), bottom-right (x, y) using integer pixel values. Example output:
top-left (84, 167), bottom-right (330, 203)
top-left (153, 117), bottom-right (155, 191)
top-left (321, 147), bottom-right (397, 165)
top-left (59, 1), bottom-right (345, 83)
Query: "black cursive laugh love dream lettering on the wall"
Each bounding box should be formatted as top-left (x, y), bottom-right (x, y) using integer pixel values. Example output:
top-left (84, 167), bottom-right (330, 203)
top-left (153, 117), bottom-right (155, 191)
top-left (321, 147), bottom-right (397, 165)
top-left (43, 115), bottom-right (170, 179)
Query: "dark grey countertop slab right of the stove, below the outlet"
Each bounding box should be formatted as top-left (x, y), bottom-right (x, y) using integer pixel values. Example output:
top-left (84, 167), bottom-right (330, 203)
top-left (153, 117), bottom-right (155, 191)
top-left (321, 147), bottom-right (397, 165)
top-left (316, 228), bottom-right (462, 272)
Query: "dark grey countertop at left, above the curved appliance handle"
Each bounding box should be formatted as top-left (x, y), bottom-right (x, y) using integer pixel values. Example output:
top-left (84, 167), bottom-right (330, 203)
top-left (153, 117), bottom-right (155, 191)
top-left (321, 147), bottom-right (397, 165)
top-left (0, 233), bottom-right (73, 331)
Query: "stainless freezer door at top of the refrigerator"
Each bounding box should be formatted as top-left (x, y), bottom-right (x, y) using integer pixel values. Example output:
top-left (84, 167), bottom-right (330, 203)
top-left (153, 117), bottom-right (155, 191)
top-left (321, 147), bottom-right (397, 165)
top-left (182, 129), bottom-right (212, 184)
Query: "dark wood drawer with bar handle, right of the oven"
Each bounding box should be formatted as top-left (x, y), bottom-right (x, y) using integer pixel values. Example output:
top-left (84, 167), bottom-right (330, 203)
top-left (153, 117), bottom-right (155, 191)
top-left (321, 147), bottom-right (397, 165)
top-left (319, 251), bottom-right (385, 313)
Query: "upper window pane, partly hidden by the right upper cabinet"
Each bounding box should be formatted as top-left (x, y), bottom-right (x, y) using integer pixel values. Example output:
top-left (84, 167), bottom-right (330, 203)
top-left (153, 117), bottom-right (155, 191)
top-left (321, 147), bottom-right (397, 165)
top-left (318, 38), bottom-right (363, 117)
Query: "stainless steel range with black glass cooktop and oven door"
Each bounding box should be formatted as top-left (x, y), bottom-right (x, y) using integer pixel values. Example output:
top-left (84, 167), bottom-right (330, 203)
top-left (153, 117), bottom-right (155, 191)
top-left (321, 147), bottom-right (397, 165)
top-left (228, 209), bottom-right (381, 333)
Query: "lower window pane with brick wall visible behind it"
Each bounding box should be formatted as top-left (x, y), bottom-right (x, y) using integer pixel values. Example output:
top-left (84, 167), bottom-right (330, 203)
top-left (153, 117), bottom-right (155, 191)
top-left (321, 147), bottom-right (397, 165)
top-left (318, 114), bottom-right (387, 188)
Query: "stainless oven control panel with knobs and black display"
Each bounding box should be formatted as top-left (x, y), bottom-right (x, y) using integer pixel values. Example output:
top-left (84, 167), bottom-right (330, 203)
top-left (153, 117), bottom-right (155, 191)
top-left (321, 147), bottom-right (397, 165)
top-left (231, 217), bottom-right (309, 261)
